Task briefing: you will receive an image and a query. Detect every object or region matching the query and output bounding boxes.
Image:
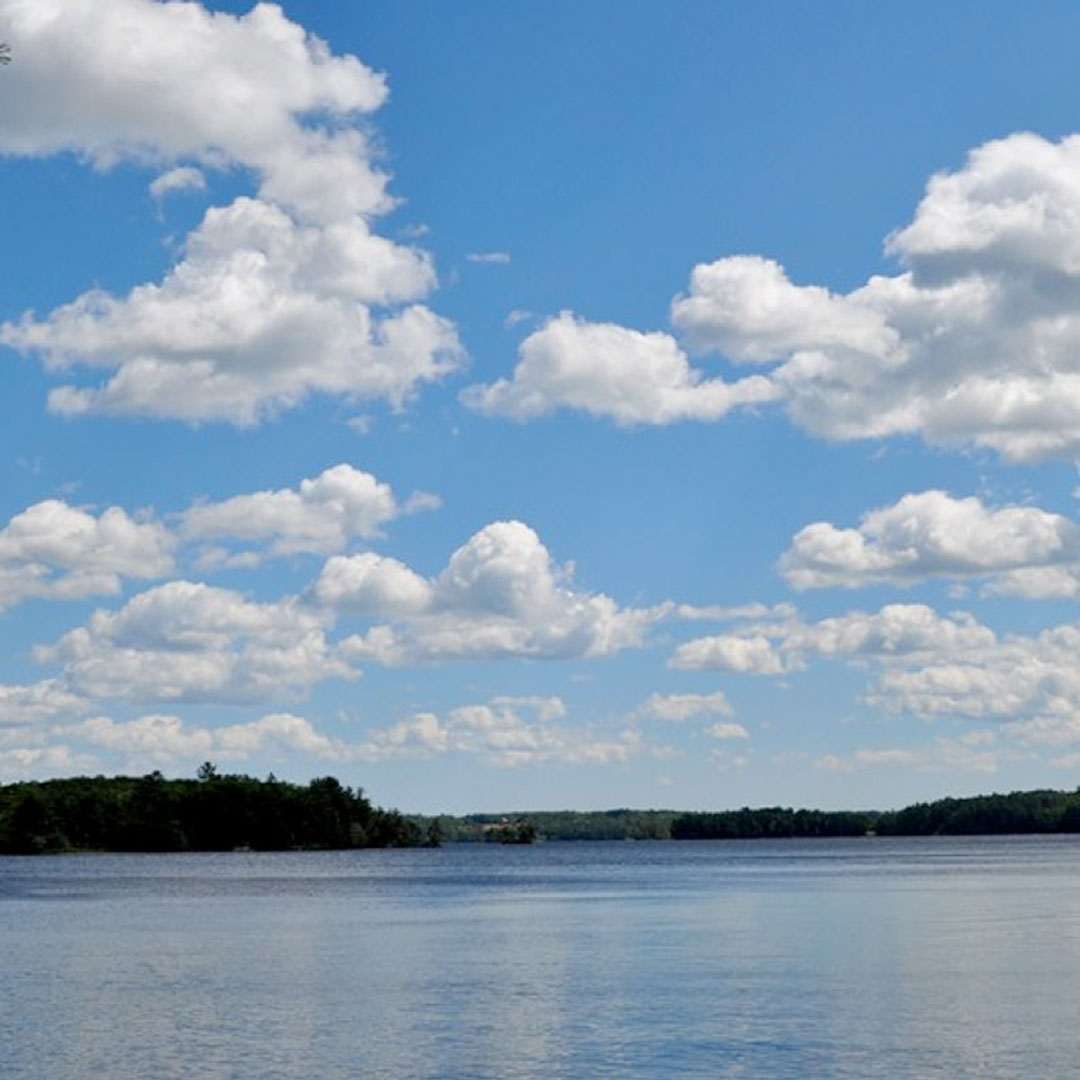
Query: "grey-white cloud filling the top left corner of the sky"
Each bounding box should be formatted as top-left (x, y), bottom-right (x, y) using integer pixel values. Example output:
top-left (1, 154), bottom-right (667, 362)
top-left (0, 0), bottom-right (388, 220)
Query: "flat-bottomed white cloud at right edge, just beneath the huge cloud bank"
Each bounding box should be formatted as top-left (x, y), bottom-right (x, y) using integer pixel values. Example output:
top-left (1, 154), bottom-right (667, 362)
top-left (780, 491), bottom-right (1080, 595)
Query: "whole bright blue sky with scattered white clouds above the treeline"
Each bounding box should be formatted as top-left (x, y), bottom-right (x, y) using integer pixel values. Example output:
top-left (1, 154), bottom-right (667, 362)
top-left (6, 0), bottom-right (1080, 812)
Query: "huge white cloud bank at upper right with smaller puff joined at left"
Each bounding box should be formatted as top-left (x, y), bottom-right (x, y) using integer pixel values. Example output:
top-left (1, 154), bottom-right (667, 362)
top-left (467, 134), bottom-right (1080, 461)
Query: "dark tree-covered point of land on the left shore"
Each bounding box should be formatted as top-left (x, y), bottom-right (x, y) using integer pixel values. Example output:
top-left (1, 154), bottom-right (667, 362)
top-left (0, 762), bottom-right (423, 854)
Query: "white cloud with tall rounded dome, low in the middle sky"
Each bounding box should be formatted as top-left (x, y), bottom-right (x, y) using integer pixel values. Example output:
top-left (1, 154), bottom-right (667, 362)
top-left (311, 522), bottom-right (669, 664)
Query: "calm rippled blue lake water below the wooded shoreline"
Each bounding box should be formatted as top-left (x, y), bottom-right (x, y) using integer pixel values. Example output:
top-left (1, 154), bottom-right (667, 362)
top-left (0, 837), bottom-right (1080, 1080)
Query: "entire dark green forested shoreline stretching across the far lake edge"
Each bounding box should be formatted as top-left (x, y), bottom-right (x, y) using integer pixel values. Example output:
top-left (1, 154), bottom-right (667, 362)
top-left (6, 762), bottom-right (1080, 854)
